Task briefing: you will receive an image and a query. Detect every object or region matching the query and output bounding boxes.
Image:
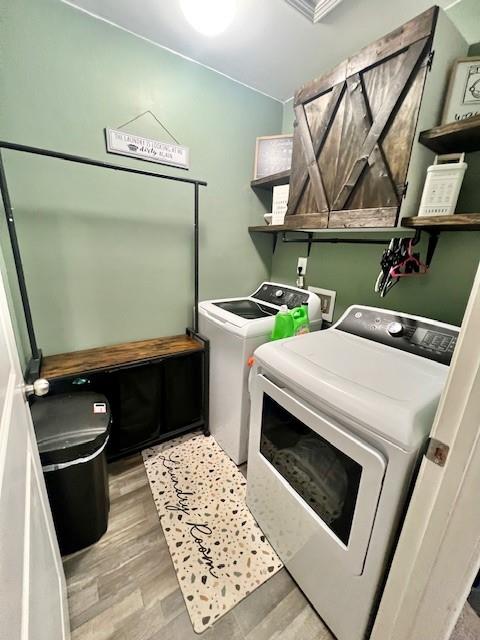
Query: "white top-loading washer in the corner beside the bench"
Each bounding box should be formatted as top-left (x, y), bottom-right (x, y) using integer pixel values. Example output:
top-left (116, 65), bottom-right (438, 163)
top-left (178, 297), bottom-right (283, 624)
top-left (199, 282), bottom-right (322, 464)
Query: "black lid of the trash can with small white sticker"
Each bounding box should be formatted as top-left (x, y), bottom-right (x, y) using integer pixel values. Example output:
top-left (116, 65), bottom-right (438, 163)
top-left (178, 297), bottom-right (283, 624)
top-left (32, 391), bottom-right (111, 466)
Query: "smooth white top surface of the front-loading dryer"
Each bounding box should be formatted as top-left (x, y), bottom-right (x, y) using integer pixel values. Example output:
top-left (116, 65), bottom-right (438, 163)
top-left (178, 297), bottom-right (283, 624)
top-left (255, 329), bottom-right (448, 450)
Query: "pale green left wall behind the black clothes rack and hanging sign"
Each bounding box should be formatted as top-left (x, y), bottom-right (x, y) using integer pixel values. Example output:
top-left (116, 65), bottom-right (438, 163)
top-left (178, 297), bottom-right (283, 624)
top-left (0, 0), bottom-right (282, 354)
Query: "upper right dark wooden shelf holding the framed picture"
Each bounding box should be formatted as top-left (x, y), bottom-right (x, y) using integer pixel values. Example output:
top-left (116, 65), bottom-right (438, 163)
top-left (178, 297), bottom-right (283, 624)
top-left (418, 116), bottom-right (480, 154)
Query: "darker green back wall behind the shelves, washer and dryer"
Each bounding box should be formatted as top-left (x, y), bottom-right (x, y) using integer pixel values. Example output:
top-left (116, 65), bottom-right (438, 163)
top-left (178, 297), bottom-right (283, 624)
top-left (272, 45), bottom-right (480, 324)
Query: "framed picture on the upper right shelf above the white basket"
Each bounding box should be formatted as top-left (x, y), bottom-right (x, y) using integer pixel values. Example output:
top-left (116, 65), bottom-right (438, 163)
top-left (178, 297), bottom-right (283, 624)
top-left (442, 56), bottom-right (480, 124)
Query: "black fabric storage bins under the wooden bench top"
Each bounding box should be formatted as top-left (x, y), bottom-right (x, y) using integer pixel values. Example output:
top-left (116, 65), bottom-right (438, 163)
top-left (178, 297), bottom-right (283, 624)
top-left (49, 350), bottom-right (208, 462)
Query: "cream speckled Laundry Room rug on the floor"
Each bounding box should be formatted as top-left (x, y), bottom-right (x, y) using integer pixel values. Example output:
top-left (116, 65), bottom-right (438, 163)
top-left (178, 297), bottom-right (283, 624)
top-left (142, 434), bottom-right (283, 633)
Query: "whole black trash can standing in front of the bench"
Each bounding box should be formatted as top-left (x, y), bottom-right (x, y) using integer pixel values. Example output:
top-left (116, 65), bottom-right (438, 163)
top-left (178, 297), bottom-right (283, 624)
top-left (32, 392), bottom-right (111, 555)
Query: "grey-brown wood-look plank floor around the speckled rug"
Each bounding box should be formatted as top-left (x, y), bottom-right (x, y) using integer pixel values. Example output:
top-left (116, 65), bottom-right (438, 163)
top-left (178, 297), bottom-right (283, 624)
top-left (64, 455), bottom-right (332, 640)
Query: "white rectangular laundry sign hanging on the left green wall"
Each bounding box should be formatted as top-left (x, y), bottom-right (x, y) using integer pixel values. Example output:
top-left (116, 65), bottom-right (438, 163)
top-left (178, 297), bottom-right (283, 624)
top-left (105, 129), bottom-right (190, 169)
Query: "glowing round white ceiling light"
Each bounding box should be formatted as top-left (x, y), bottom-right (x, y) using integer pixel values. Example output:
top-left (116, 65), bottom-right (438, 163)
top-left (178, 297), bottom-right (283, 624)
top-left (180, 0), bottom-right (237, 36)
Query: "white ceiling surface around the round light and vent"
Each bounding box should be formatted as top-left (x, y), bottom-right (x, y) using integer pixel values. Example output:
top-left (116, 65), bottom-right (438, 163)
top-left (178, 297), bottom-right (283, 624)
top-left (64, 0), bottom-right (472, 101)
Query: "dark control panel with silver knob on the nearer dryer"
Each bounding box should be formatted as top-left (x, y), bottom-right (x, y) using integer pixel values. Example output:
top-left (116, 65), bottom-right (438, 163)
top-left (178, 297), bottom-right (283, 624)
top-left (335, 307), bottom-right (460, 365)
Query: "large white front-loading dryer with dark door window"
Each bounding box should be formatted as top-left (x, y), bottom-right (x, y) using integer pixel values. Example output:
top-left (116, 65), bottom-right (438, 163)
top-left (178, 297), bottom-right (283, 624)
top-left (247, 306), bottom-right (459, 640)
